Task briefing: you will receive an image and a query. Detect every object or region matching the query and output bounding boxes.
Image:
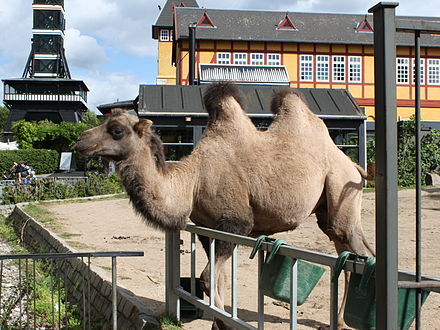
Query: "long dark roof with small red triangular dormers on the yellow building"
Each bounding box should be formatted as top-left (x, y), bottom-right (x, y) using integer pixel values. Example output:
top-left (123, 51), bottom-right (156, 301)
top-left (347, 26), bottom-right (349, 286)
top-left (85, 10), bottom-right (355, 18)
top-left (176, 7), bottom-right (440, 47)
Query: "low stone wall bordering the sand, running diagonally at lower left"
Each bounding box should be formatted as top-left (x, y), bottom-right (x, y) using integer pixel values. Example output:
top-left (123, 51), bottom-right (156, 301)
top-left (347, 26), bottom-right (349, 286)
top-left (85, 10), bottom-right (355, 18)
top-left (9, 206), bottom-right (159, 329)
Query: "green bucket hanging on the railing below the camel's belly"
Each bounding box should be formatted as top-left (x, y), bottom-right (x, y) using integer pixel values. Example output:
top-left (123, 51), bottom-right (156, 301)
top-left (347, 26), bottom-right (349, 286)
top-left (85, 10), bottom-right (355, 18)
top-left (250, 235), bottom-right (325, 306)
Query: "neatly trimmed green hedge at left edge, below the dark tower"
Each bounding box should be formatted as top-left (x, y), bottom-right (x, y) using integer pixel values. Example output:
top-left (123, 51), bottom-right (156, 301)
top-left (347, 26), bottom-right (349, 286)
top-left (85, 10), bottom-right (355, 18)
top-left (0, 149), bottom-right (60, 174)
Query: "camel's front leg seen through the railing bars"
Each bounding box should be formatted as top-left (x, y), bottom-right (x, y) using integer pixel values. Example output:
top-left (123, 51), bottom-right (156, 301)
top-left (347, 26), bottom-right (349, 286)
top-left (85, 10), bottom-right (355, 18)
top-left (199, 219), bottom-right (253, 329)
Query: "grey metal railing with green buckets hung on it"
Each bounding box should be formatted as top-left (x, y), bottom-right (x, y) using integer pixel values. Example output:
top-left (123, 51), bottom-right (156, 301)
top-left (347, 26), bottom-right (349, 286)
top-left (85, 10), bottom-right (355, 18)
top-left (165, 225), bottom-right (440, 329)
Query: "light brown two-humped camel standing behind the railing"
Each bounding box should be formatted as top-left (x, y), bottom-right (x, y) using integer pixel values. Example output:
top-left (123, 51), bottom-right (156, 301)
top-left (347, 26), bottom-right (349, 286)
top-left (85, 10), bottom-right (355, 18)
top-left (75, 83), bottom-right (374, 329)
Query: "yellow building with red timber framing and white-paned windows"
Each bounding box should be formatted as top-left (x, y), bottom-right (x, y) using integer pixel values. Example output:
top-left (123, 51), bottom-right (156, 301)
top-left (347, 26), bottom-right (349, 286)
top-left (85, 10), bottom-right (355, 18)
top-left (153, 0), bottom-right (440, 128)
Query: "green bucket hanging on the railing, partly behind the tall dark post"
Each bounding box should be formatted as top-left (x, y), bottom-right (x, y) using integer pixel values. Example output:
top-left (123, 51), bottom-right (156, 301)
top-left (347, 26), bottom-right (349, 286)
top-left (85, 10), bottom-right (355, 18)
top-left (332, 251), bottom-right (429, 330)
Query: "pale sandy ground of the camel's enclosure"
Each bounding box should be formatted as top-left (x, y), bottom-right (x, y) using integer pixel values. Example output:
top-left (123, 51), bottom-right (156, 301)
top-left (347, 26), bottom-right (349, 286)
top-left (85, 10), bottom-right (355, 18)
top-left (38, 188), bottom-right (440, 329)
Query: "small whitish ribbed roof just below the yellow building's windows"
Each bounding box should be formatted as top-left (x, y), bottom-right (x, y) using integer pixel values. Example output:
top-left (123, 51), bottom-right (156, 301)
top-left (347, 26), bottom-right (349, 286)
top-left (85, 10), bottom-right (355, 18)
top-left (199, 64), bottom-right (290, 85)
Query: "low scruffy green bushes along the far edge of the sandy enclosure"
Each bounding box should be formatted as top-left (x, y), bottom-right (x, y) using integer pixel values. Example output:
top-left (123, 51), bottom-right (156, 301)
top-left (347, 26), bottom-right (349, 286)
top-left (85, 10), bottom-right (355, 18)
top-left (1, 174), bottom-right (123, 204)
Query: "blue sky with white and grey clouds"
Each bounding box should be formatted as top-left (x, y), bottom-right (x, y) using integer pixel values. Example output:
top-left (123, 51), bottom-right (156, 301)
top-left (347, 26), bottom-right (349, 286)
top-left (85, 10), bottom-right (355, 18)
top-left (0, 0), bottom-right (440, 111)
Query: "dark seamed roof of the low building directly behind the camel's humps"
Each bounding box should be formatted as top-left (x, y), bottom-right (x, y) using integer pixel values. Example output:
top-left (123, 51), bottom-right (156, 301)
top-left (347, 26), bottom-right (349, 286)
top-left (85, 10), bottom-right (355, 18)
top-left (138, 85), bottom-right (365, 119)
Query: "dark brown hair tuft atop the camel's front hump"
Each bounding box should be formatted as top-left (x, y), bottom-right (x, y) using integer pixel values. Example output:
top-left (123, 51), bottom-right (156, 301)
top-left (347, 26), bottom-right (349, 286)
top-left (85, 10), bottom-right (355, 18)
top-left (203, 83), bottom-right (246, 120)
